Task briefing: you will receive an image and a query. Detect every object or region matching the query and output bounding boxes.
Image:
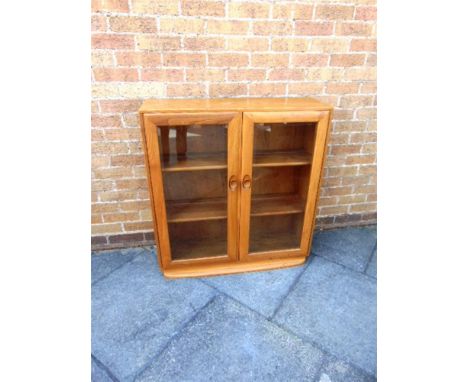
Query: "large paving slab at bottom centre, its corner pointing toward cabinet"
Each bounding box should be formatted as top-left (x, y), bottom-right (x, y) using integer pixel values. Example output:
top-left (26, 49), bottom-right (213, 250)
top-left (136, 295), bottom-right (324, 382)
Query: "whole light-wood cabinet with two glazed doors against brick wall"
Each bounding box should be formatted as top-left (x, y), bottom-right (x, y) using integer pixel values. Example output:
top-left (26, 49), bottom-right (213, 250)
top-left (140, 98), bottom-right (332, 278)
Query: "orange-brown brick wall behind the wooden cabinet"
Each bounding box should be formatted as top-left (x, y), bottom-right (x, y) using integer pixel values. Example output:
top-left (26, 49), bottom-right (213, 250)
top-left (91, 0), bottom-right (377, 248)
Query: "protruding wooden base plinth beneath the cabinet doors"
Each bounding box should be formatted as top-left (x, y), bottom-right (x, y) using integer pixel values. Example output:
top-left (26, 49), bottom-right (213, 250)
top-left (163, 256), bottom-right (307, 279)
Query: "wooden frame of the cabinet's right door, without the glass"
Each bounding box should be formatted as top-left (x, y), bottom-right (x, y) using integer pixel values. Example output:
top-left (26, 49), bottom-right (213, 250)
top-left (239, 110), bottom-right (331, 261)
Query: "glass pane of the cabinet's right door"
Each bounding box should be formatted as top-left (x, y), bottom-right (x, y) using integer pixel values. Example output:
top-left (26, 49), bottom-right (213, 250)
top-left (249, 123), bottom-right (315, 253)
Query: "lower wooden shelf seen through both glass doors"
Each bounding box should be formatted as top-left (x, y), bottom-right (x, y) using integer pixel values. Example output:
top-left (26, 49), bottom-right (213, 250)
top-left (167, 194), bottom-right (305, 223)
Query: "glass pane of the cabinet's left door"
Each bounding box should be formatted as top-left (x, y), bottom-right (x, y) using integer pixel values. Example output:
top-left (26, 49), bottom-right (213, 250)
top-left (158, 125), bottom-right (228, 260)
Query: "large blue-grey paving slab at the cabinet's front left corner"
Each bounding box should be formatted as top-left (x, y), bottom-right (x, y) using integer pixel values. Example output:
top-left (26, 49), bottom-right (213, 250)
top-left (92, 251), bottom-right (216, 381)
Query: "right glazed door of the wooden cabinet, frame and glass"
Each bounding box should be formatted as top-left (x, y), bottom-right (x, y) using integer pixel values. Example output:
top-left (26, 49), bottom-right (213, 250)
top-left (239, 111), bottom-right (329, 261)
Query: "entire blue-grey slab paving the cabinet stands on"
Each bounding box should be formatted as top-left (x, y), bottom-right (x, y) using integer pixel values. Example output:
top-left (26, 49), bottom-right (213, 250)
top-left (92, 226), bottom-right (377, 382)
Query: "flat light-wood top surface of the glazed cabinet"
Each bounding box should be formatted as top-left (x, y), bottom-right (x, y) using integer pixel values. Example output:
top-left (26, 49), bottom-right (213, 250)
top-left (139, 98), bottom-right (332, 113)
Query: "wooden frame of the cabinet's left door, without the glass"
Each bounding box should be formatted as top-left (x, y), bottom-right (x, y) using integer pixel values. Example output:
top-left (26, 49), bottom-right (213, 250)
top-left (141, 111), bottom-right (242, 269)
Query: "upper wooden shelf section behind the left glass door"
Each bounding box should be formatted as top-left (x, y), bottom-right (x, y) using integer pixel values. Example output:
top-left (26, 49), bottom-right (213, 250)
top-left (161, 153), bottom-right (227, 172)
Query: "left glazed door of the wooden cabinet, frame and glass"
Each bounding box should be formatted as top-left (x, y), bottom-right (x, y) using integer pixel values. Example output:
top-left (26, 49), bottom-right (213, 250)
top-left (142, 112), bottom-right (242, 268)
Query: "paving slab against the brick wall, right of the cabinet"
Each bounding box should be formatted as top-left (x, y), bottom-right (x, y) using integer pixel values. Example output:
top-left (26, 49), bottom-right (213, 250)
top-left (312, 226), bottom-right (377, 272)
